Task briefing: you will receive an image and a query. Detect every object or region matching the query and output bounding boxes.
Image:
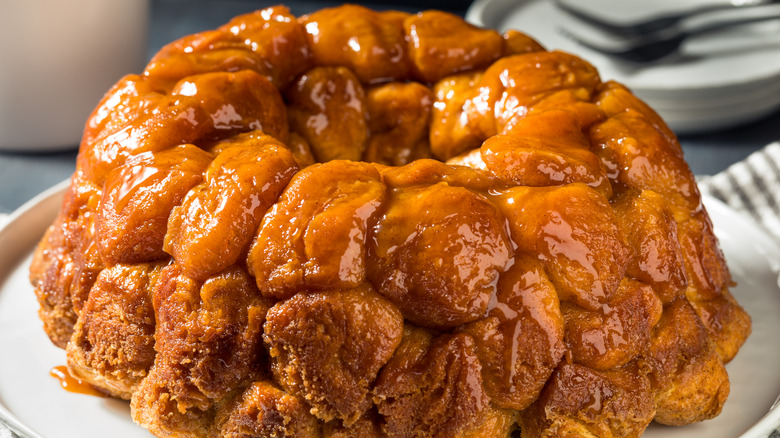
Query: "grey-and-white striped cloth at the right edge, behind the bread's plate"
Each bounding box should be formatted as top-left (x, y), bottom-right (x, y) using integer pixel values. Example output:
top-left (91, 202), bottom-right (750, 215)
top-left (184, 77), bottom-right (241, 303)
top-left (699, 141), bottom-right (780, 242)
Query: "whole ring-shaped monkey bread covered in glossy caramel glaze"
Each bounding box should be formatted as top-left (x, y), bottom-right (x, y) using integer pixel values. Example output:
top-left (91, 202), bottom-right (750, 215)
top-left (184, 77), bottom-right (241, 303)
top-left (31, 5), bottom-right (750, 438)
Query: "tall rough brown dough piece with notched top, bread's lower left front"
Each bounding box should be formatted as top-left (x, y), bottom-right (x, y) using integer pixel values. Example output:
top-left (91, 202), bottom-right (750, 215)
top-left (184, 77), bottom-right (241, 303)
top-left (131, 264), bottom-right (270, 436)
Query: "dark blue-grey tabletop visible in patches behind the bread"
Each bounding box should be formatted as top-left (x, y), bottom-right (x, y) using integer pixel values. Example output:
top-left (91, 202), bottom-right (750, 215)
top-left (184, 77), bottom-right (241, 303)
top-left (0, 0), bottom-right (780, 214)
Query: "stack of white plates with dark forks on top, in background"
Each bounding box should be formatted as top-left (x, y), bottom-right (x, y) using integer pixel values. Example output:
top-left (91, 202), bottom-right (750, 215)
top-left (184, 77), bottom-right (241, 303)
top-left (466, 0), bottom-right (780, 134)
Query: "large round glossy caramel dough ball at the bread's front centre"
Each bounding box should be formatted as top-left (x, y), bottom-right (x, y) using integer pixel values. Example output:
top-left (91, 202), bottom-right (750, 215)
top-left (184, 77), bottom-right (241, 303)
top-left (368, 182), bottom-right (512, 328)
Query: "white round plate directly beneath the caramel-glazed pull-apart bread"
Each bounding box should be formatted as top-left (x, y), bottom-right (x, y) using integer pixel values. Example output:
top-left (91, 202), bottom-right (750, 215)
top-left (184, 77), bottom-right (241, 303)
top-left (0, 185), bottom-right (780, 438)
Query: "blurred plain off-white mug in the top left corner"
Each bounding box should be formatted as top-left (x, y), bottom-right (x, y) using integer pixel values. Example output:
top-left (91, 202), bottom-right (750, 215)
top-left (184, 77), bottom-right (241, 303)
top-left (0, 0), bottom-right (149, 151)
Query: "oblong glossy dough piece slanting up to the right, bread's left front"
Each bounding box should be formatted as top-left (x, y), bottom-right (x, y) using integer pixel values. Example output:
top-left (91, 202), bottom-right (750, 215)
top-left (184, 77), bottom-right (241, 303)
top-left (163, 136), bottom-right (298, 280)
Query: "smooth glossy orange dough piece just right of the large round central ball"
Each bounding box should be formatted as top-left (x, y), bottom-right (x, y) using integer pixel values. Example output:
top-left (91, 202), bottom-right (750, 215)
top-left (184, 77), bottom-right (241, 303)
top-left (497, 183), bottom-right (630, 311)
